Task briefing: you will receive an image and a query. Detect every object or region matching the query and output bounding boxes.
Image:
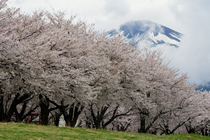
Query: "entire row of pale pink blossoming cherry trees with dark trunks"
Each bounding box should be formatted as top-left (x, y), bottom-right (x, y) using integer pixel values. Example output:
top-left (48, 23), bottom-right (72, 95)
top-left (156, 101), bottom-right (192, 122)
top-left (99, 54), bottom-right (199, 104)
top-left (0, 0), bottom-right (209, 134)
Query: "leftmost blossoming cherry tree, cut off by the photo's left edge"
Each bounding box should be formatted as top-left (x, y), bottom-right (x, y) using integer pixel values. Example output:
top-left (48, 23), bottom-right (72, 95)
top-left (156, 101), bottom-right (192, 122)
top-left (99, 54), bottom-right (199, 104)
top-left (0, 0), bottom-right (46, 121)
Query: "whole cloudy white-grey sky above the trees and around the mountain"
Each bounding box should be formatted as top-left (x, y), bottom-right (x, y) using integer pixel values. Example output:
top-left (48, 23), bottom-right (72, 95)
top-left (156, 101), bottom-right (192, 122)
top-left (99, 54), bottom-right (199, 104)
top-left (8, 0), bottom-right (210, 84)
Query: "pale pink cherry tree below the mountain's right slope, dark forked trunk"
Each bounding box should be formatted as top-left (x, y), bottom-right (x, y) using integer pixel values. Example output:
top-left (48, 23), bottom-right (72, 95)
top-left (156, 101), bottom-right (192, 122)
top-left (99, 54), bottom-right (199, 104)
top-left (122, 50), bottom-right (203, 133)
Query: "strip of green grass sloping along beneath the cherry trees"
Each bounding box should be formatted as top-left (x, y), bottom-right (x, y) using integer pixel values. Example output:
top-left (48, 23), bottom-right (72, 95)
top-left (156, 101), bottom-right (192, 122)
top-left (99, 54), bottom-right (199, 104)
top-left (0, 123), bottom-right (210, 140)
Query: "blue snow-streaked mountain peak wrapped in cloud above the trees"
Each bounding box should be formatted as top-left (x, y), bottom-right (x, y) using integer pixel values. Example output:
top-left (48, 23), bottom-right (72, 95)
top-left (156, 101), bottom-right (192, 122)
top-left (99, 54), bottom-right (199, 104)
top-left (107, 20), bottom-right (183, 47)
